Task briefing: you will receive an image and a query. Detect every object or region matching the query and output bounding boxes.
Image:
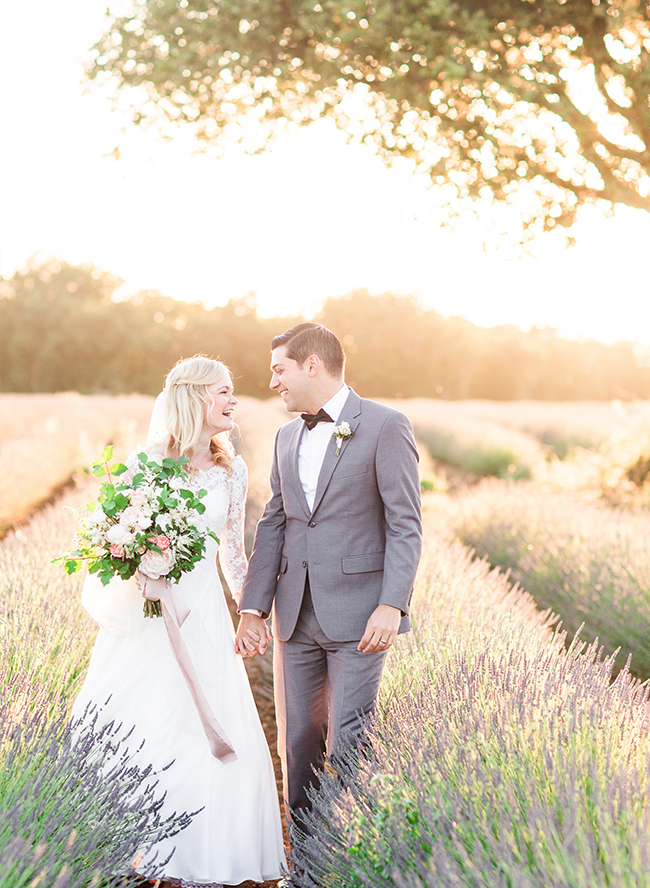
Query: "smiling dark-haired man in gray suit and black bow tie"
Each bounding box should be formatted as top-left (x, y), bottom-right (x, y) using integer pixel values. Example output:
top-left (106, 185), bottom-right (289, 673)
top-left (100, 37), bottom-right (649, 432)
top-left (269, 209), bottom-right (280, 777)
top-left (236, 323), bottom-right (422, 818)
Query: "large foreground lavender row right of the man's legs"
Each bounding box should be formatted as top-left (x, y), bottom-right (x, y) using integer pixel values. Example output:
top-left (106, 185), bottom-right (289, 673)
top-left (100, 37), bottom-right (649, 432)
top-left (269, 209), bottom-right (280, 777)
top-left (296, 519), bottom-right (650, 888)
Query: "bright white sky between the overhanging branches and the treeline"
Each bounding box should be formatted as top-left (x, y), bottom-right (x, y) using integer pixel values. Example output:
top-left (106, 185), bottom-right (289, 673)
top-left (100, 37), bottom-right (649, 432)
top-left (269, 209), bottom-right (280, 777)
top-left (0, 0), bottom-right (650, 345)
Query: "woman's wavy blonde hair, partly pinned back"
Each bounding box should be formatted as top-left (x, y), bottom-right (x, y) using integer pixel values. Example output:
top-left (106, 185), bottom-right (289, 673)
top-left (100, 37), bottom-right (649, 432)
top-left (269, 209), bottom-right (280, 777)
top-left (165, 355), bottom-right (235, 469)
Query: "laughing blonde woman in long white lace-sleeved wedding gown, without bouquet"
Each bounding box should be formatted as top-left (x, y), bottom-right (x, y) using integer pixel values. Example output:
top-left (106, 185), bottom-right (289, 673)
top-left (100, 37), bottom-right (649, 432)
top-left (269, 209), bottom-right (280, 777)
top-left (73, 355), bottom-right (285, 888)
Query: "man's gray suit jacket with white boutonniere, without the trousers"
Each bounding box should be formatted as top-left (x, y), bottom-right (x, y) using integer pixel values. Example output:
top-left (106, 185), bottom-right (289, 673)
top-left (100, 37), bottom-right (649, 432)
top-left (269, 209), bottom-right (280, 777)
top-left (240, 391), bottom-right (422, 642)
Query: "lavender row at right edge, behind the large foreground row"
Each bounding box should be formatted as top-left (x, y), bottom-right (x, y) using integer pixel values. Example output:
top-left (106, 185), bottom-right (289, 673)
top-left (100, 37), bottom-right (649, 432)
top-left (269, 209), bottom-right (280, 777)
top-left (450, 483), bottom-right (650, 678)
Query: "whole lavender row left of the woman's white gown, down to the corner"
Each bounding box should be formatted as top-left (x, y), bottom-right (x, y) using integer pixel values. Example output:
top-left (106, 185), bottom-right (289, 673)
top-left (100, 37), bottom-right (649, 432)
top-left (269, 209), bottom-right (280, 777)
top-left (0, 491), bottom-right (187, 888)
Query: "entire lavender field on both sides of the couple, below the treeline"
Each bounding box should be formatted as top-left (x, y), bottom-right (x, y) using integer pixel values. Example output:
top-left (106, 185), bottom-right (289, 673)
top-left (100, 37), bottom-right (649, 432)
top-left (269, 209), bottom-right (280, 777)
top-left (0, 396), bottom-right (650, 888)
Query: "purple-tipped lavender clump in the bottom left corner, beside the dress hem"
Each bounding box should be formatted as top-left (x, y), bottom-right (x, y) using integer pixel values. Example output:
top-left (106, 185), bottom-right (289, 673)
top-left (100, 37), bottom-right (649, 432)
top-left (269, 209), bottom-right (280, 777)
top-left (0, 692), bottom-right (191, 888)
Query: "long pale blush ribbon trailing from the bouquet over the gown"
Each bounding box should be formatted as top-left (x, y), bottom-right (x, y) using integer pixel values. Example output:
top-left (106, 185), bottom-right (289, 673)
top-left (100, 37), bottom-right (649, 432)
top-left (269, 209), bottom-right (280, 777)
top-left (140, 573), bottom-right (237, 764)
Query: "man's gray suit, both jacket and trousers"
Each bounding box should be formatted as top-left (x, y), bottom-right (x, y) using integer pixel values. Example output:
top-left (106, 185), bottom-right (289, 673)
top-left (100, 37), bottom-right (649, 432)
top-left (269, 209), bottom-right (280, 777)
top-left (240, 391), bottom-right (422, 809)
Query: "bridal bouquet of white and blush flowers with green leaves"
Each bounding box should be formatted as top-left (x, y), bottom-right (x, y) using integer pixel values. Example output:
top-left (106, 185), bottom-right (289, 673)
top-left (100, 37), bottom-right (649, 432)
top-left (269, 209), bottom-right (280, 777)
top-left (53, 447), bottom-right (219, 616)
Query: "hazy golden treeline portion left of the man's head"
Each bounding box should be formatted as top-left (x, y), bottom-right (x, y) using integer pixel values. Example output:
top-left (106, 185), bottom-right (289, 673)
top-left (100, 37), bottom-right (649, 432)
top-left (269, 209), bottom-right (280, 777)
top-left (0, 261), bottom-right (284, 397)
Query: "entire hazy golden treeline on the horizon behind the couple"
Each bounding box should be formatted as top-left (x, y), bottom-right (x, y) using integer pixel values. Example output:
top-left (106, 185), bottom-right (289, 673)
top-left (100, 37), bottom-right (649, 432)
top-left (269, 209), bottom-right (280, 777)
top-left (0, 260), bottom-right (650, 400)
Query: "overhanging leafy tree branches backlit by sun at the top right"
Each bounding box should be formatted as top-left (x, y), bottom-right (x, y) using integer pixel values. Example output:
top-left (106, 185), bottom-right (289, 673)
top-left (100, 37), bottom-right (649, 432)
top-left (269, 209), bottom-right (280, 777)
top-left (89, 0), bottom-right (650, 231)
